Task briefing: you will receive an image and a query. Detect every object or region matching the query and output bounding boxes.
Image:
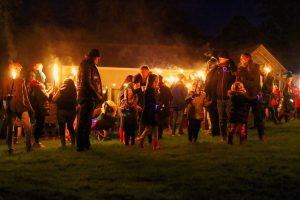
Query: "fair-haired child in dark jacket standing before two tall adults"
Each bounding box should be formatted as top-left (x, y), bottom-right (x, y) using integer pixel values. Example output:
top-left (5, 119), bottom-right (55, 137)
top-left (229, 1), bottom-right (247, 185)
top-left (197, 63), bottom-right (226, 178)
top-left (228, 81), bottom-right (251, 144)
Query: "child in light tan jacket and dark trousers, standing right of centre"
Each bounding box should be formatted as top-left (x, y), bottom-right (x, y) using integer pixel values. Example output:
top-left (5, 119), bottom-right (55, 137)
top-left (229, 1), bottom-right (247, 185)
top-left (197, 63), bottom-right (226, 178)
top-left (185, 80), bottom-right (205, 142)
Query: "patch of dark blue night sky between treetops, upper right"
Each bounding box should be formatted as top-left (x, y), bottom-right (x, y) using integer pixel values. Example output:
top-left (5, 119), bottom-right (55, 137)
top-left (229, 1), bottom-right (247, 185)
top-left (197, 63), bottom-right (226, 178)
top-left (184, 0), bottom-right (261, 35)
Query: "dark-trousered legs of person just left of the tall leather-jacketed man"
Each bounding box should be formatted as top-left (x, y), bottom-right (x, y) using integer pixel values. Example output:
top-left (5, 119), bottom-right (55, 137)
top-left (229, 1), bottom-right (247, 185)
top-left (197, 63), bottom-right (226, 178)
top-left (57, 110), bottom-right (76, 146)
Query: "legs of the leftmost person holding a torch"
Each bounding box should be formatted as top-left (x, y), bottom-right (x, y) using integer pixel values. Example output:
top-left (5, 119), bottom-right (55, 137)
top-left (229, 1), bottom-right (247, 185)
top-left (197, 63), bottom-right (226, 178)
top-left (7, 111), bottom-right (32, 152)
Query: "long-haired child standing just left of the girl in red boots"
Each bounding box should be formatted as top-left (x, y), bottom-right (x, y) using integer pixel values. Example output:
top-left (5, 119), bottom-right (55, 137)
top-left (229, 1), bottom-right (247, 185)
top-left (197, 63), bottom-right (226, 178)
top-left (120, 87), bottom-right (142, 146)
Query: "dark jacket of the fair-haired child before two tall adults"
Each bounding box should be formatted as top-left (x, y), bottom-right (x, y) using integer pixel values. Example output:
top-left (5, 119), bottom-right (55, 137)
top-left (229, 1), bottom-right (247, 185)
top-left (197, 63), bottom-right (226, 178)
top-left (229, 92), bottom-right (251, 124)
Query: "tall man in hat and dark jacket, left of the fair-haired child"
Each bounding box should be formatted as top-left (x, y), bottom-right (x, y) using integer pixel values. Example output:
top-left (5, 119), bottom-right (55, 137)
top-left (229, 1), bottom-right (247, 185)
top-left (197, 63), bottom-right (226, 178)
top-left (217, 51), bottom-right (236, 141)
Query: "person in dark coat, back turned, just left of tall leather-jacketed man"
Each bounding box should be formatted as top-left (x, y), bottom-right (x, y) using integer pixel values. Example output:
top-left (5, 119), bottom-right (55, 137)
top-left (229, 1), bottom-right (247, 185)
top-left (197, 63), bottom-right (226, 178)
top-left (52, 78), bottom-right (77, 147)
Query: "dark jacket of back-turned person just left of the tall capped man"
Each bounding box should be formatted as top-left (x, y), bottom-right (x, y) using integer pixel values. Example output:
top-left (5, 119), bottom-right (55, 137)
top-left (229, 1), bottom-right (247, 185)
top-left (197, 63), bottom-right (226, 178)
top-left (52, 79), bottom-right (77, 111)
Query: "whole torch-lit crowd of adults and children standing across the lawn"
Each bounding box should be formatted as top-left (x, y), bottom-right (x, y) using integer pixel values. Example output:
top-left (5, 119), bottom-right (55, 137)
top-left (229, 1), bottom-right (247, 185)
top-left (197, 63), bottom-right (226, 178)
top-left (0, 49), bottom-right (300, 153)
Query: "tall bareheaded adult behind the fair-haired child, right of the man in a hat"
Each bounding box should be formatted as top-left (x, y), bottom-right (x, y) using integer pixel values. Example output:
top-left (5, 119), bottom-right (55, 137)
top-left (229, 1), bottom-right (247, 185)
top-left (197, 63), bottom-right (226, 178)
top-left (237, 53), bottom-right (264, 140)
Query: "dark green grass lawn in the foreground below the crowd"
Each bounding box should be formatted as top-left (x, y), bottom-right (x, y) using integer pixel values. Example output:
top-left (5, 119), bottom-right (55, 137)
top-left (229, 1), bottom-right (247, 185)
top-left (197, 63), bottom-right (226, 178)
top-left (0, 120), bottom-right (300, 199)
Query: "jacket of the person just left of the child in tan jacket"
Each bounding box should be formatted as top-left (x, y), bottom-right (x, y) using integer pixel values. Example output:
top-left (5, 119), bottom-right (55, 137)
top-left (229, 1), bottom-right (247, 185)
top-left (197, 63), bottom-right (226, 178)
top-left (171, 82), bottom-right (188, 110)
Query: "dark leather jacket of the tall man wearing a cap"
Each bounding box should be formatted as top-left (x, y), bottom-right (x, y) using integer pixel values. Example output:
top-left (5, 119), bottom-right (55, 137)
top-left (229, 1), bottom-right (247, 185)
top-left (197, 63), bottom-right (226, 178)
top-left (77, 58), bottom-right (102, 104)
